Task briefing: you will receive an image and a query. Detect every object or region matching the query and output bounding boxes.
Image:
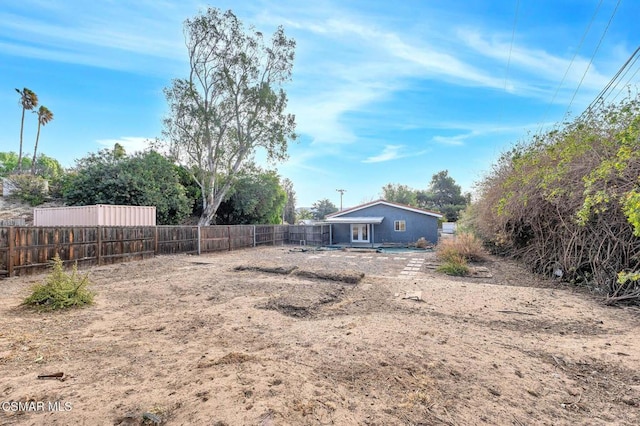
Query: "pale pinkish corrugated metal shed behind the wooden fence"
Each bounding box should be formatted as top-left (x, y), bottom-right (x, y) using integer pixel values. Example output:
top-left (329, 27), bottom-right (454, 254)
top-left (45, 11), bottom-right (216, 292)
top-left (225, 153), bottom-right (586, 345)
top-left (33, 204), bottom-right (156, 226)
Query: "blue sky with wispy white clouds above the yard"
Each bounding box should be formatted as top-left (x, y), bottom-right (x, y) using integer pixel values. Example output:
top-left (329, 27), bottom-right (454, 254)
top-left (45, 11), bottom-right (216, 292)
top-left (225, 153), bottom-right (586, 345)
top-left (0, 0), bottom-right (640, 207)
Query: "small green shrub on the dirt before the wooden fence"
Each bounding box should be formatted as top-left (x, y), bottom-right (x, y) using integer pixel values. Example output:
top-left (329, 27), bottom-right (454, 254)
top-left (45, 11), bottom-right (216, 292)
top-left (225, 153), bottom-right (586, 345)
top-left (22, 255), bottom-right (94, 311)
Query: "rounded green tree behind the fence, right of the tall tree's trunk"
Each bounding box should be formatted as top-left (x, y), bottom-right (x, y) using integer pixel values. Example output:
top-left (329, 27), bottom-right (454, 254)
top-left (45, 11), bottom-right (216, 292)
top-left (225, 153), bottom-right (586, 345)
top-left (216, 167), bottom-right (286, 225)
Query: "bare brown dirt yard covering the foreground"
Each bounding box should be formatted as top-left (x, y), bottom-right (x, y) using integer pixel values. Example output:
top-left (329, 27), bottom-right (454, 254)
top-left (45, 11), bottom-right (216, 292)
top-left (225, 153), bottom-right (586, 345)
top-left (0, 247), bottom-right (640, 426)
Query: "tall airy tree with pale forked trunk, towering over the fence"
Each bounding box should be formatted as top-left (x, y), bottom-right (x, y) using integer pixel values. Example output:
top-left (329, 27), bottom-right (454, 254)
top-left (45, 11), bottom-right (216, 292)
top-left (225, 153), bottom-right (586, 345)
top-left (164, 8), bottom-right (295, 225)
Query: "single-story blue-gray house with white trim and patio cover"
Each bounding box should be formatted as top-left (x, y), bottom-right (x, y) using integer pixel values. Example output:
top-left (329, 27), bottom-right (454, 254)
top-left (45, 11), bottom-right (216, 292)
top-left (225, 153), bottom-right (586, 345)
top-left (325, 200), bottom-right (442, 246)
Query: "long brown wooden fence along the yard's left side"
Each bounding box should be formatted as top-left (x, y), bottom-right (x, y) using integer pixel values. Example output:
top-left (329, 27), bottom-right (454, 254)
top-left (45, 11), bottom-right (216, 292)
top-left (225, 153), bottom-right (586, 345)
top-left (0, 225), bottom-right (330, 277)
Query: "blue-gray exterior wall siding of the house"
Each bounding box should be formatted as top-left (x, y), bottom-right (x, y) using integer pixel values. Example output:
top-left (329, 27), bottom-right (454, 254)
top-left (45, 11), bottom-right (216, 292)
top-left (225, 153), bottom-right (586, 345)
top-left (333, 204), bottom-right (438, 244)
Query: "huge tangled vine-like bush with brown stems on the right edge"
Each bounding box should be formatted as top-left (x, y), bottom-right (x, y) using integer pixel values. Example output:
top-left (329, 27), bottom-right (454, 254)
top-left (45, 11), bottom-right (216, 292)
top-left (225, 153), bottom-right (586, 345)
top-left (474, 99), bottom-right (640, 300)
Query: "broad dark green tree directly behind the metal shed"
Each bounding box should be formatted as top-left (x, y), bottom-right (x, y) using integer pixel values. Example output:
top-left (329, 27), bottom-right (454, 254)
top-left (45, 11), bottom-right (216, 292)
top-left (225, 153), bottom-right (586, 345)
top-left (62, 149), bottom-right (191, 225)
